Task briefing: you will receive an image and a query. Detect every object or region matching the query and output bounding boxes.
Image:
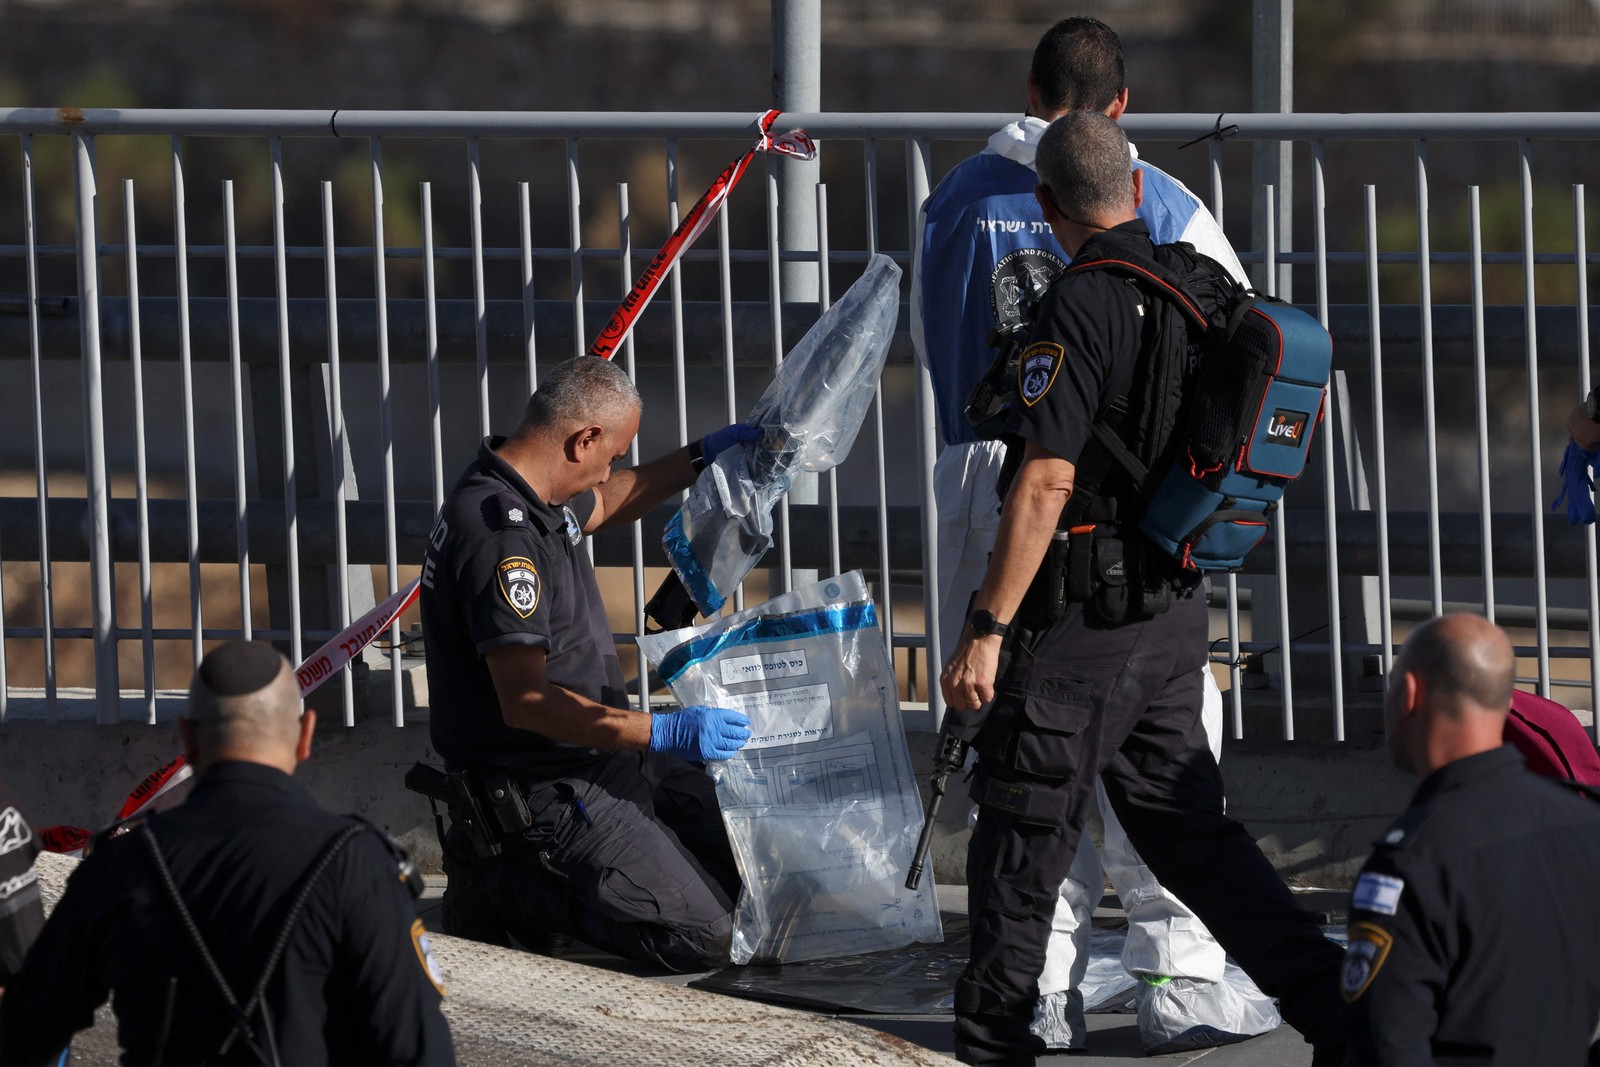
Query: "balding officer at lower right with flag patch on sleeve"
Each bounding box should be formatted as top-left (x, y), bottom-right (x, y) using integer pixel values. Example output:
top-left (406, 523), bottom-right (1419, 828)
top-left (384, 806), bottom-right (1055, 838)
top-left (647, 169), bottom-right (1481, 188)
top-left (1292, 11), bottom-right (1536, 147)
top-left (1341, 614), bottom-right (1600, 1064)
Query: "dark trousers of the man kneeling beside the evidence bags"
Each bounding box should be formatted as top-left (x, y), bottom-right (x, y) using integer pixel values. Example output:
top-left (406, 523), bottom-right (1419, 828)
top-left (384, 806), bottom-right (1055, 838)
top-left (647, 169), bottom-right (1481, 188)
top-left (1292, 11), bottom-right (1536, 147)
top-left (478, 752), bottom-right (739, 971)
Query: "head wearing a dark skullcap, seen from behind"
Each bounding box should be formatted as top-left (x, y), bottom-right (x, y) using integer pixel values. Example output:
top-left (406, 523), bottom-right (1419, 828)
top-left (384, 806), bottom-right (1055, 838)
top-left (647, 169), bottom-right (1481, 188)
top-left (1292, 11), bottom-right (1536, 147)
top-left (182, 641), bottom-right (306, 769)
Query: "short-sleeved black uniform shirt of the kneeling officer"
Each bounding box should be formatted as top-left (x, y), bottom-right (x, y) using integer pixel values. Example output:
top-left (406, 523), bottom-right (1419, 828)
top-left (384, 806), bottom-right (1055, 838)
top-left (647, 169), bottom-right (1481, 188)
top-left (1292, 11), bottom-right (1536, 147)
top-left (422, 437), bottom-right (627, 774)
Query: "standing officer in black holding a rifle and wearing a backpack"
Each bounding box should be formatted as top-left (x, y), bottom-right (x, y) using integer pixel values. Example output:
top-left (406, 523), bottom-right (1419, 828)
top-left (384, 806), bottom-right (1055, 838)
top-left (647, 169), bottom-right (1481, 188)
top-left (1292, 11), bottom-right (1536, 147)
top-left (941, 112), bottom-right (1342, 1064)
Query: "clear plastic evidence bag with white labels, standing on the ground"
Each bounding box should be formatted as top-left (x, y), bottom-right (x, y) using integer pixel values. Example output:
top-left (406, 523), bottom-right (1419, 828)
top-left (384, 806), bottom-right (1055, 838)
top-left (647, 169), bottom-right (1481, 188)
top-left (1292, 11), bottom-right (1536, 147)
top-left (638, 571), bottom-right (944, 963)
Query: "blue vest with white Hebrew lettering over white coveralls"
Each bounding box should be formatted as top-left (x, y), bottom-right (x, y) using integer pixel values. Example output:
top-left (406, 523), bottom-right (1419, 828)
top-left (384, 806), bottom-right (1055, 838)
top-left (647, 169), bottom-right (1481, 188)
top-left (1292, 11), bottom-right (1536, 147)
top-left (920, 152), bottom-right (1206, 445)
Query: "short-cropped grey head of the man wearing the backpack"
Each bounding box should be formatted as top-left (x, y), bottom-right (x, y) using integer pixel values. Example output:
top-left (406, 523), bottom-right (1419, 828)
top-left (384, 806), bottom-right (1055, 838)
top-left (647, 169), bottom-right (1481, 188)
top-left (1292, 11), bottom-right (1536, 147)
top-left (1037, 110), bottom-right (1133, 224)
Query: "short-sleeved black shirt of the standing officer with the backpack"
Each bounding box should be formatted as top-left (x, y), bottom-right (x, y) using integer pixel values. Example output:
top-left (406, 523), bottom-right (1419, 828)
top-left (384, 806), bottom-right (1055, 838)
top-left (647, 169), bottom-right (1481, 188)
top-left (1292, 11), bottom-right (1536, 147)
top-left (1005, 219), bottom-right (1155, 462)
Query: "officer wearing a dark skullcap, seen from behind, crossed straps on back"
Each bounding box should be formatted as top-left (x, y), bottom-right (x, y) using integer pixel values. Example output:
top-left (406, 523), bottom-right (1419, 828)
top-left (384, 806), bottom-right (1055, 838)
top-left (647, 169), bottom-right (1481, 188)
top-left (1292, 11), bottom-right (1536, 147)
top-left (0, 641), bottom-right (454, 1064)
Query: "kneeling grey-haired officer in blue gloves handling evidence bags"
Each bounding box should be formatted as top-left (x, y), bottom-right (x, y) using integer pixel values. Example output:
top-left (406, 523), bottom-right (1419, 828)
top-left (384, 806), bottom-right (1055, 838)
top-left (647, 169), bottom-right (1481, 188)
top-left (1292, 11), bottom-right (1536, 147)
top-left (422, 357), bottom-right (758, 971)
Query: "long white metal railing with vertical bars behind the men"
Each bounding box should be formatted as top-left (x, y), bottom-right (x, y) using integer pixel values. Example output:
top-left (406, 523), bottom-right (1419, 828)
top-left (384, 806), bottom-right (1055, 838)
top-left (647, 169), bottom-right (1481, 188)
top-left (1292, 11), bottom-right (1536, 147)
top-left (0, 109), bottom-right (1600, 739)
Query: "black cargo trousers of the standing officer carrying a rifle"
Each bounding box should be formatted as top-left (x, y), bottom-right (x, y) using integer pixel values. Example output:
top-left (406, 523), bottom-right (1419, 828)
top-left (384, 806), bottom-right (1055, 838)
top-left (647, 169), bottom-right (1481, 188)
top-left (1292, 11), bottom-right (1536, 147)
top-left (955, 595), bottom-right (1342, 1064)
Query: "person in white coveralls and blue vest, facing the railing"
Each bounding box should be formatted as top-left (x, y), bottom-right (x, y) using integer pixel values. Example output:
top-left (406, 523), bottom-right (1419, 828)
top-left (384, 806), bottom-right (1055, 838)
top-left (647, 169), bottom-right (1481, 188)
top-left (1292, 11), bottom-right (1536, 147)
top-left (910, 18), bottom-right (1280, 1051)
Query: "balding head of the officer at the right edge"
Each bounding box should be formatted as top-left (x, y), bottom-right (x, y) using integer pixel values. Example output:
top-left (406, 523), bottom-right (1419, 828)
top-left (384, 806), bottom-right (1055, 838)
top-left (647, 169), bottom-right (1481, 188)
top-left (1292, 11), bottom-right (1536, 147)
top-left (1384, 614), bottom-right (1517, 776)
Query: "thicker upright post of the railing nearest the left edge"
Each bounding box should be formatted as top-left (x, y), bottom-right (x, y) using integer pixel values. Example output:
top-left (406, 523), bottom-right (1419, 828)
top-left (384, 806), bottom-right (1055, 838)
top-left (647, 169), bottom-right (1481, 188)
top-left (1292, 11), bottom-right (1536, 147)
top-left (72, 133), bottom-right (122, 723)
